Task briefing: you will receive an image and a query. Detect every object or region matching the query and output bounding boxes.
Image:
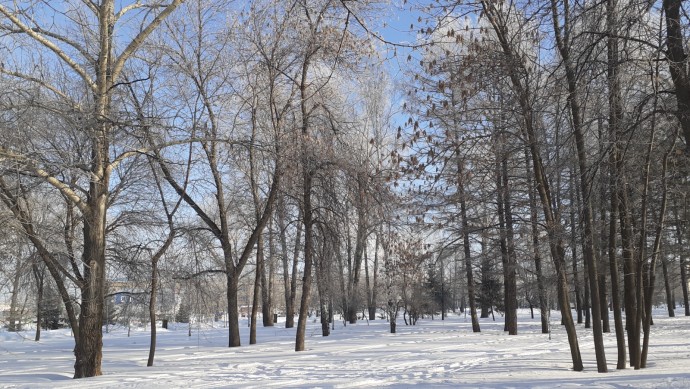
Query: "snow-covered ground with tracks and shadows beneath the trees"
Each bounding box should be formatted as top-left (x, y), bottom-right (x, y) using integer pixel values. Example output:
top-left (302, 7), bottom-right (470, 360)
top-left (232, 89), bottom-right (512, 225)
top-left (0, 311), bottom-right (690, 389)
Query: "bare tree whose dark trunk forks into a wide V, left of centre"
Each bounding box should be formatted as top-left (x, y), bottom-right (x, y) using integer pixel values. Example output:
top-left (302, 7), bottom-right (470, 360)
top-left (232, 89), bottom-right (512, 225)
top-left (148, 2), bottom-right (281, 347)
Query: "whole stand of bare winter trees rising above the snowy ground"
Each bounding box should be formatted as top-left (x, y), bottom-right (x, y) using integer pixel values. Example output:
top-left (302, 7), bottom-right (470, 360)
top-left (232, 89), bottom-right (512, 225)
top-left (0, 0), bottom-right (690, 378)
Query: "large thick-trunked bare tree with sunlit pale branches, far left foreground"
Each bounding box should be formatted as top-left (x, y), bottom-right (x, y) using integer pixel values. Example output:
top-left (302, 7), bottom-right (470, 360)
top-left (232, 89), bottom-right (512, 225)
top-left (0, 0), bottom-right (182, 378)
